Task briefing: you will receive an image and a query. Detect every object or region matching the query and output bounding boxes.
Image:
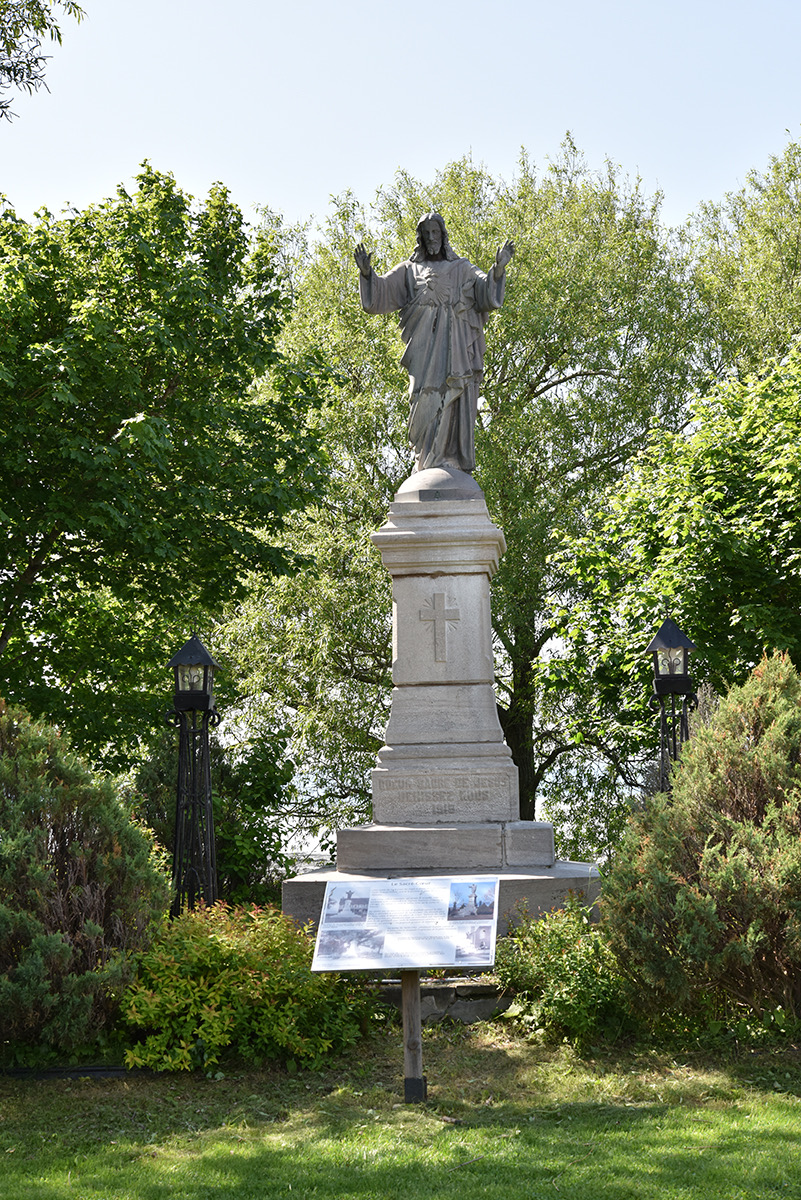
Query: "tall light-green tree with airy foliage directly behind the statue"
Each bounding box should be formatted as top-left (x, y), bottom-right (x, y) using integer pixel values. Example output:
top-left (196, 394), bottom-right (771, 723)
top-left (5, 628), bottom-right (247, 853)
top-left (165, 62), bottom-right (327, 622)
top-left (215, 143), bottom-right (700, 840)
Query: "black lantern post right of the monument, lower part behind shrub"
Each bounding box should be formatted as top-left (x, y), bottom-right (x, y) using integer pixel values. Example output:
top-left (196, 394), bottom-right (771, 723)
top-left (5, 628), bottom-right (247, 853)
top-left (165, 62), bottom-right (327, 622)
top-left (648, 617), bottom-right (698, 792)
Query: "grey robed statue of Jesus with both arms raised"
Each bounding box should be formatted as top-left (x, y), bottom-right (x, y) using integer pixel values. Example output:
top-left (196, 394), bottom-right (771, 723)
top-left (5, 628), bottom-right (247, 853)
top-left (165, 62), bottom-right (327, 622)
top-left (354, 212), bottom-right (514, 472)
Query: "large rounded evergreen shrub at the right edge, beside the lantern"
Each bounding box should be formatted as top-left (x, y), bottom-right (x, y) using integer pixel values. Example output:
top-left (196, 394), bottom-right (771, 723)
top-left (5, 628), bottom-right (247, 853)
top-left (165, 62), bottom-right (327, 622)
top-left (602, 655), bottom-right (801, 1018)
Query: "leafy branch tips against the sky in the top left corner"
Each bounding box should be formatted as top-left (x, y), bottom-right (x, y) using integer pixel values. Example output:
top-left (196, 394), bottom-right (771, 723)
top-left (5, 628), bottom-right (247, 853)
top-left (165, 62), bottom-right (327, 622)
top-left (0, 0), bottom-right (84, 120)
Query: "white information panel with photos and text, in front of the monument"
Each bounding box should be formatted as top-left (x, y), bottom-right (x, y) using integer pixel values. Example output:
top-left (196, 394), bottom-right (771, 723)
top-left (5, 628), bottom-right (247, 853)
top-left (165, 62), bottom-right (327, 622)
top-left (312, 875), bottom-right (499, 971)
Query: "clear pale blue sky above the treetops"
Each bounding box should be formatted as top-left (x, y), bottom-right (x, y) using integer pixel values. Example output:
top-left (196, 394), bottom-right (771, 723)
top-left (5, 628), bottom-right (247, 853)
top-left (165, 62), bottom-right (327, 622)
top-left (0, 0), bottom-right (801, 222)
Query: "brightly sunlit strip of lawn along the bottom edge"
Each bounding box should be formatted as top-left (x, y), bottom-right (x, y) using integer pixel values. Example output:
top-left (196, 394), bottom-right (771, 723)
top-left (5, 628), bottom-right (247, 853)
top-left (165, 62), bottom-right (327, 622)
top-left (6, 1104), bottom-right (801, 1200)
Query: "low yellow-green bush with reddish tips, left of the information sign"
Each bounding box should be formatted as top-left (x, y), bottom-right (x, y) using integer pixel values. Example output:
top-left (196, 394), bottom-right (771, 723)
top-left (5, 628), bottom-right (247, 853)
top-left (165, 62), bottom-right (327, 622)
top-left (125, 904), bottom-right (372, 1070)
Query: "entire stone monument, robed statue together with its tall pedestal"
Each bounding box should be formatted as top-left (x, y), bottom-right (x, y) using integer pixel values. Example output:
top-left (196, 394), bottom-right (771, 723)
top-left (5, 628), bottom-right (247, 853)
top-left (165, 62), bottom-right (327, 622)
top-left (283, 214), bottom-right (600, 932)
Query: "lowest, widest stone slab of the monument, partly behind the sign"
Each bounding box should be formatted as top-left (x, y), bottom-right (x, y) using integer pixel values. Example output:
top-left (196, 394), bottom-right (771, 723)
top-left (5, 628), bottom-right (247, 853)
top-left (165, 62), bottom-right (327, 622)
top-left (282, 862), bottom-right (601, 937)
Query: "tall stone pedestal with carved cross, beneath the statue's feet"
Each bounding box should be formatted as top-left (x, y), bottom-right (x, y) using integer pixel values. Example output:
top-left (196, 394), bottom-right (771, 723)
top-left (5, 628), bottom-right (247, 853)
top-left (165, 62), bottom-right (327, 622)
top-left (283, 468), bottom-right (598, 919)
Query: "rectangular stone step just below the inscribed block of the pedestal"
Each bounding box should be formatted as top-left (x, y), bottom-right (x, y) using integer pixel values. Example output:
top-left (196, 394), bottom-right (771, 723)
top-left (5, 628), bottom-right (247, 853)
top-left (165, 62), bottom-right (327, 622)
top-left (337, 821), bottom-right (554, 875)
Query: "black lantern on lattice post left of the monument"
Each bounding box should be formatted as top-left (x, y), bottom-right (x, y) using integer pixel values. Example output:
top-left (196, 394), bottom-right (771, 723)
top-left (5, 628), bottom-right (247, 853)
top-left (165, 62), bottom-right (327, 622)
top-left (167, 634), bottom-right (219, 917)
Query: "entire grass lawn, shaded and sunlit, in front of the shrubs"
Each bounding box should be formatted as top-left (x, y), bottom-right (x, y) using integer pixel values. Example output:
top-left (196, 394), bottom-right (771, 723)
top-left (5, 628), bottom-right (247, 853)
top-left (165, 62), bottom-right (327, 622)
top-left (0, 1024), bottom-right (801, 1200)
